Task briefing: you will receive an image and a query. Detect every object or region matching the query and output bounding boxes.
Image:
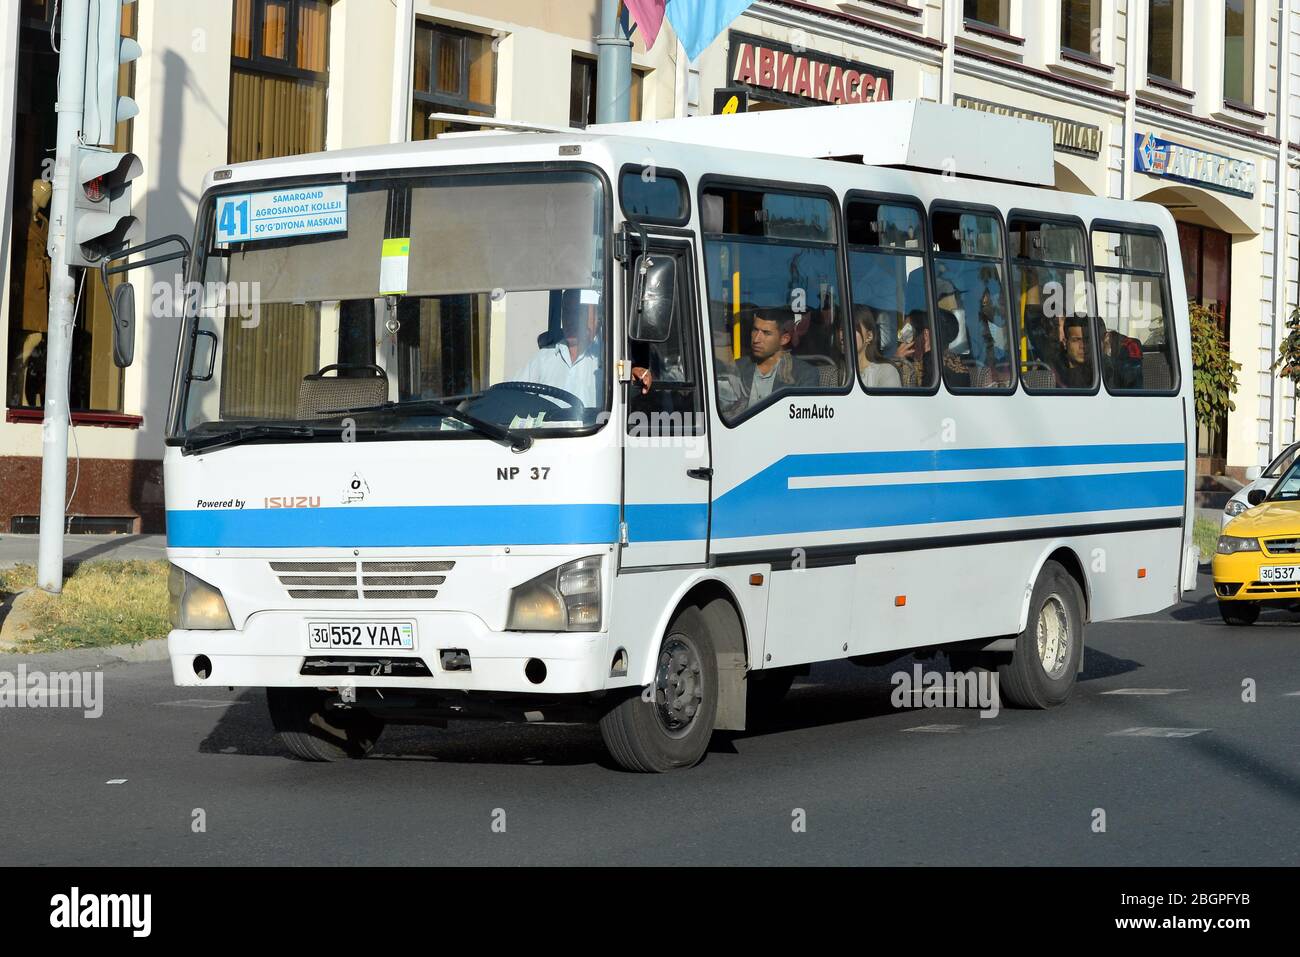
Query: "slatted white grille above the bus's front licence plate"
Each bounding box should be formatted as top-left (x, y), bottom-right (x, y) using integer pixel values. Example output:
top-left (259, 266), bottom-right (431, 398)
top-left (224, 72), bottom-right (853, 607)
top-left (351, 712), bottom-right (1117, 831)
top-left (270, 562), bottom-right (456, 601)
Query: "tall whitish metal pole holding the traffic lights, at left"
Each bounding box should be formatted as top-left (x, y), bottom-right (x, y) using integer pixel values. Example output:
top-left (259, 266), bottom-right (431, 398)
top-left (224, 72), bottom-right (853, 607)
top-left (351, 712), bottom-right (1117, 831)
top-left (36, 0), bottom-right (90, 593)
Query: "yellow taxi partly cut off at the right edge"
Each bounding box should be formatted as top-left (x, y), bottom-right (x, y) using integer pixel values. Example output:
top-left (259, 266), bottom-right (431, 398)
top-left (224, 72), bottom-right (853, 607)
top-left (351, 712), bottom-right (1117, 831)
top-left (1214, 467), bottom-right (1300, 624)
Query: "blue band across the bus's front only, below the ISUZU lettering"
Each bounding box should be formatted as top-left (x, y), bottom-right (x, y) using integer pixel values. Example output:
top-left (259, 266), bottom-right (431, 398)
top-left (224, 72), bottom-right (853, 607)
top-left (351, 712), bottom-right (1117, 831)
top-left (166, 503), bottom-right (619, 549)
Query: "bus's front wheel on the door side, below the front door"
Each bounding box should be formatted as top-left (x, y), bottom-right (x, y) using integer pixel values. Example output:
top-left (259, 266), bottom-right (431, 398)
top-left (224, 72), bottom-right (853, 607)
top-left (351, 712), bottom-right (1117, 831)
top-left (601, 606), bottom-right (718, 772)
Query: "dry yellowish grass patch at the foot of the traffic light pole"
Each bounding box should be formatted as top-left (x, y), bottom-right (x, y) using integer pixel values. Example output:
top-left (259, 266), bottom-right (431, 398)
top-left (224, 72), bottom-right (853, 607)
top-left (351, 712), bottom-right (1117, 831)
top-left (0, 562), bottom-right (172, 651)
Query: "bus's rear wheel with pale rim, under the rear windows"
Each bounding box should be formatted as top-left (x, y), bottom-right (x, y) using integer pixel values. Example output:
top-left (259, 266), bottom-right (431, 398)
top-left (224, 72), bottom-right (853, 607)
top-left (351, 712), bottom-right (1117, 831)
top-left (997, 562), bottom-right (1083, 710)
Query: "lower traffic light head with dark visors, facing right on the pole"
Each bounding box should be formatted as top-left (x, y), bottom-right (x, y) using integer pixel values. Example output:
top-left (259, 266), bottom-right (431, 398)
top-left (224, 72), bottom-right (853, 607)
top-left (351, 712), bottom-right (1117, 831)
top-left (68, 146), bottom-right (144, 267)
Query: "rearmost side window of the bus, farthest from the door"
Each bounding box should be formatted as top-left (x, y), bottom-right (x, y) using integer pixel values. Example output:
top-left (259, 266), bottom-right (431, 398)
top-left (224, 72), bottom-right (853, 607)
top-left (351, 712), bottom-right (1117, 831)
top-left (1092, 226), bottom-right (1178, 394)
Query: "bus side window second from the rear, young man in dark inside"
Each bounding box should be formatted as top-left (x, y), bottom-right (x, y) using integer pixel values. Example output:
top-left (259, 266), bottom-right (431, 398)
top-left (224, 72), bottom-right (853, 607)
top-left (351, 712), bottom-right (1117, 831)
top-left (1008, 215), bottom-right (1097, 394)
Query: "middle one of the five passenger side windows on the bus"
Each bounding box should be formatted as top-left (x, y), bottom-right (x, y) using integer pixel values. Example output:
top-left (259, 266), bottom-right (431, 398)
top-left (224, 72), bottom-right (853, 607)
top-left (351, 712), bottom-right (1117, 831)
top-left (931, 208), bottom-right (1017, 393)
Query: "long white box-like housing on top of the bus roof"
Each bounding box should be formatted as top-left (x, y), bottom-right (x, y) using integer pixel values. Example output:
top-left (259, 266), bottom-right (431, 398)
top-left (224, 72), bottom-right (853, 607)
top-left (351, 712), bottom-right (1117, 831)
top-left (588, 100), bottom-right (1056, 186)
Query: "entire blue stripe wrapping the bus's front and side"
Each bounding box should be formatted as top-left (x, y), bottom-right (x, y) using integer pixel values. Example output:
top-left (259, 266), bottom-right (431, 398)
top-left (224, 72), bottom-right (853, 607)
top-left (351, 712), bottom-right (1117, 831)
top-left (166, 443), bottom-right (1186, 547)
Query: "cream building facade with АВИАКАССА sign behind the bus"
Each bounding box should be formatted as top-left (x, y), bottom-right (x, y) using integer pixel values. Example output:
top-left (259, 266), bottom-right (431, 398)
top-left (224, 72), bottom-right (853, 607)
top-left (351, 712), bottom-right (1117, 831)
top-left (0, 0), bottom-right (1300, 532)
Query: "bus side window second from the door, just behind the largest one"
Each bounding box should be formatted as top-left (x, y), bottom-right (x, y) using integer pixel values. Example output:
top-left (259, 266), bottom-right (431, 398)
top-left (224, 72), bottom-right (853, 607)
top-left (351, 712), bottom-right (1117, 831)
top-left (844, 198), bottom-right (939, 391)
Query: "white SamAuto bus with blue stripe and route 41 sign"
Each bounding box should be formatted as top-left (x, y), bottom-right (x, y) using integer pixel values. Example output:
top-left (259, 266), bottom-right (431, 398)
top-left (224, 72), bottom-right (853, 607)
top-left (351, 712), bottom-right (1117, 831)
top-left (111, 103), bottom-right (1196, 771)
